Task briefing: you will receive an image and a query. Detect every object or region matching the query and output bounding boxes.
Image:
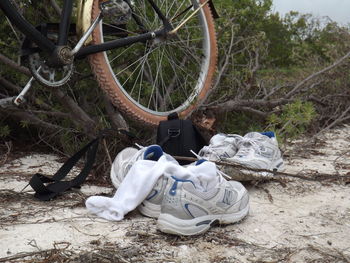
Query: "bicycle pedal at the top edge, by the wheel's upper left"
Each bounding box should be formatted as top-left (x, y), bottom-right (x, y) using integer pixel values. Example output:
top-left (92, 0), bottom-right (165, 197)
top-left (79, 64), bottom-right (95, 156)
top-left (100, 0), bottom-right (131, 25)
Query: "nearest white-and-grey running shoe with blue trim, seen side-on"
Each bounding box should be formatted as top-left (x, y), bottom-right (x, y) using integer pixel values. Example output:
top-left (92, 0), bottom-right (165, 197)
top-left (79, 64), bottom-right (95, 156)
top-left (157, 165), bottom-right (249, 236)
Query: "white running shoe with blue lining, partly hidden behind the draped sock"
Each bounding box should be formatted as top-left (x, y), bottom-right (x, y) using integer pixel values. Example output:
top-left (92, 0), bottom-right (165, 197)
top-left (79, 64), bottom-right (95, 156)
top-left (111, 145), bottom-right (177, 218)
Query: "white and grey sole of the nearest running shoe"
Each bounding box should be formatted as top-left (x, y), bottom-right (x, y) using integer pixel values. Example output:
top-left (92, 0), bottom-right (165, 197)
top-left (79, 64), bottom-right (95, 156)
top-left (157, 204), bottom-right (249, 236)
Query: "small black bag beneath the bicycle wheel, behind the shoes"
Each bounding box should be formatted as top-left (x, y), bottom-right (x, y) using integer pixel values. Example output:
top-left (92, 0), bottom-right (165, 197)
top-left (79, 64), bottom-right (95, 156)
top-left (157, 113), bottom-right (207, 165)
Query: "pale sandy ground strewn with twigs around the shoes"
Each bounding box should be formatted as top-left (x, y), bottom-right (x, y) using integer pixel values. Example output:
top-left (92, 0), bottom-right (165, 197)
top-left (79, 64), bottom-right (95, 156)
top-left (0, 126), bottom-right (350, 263)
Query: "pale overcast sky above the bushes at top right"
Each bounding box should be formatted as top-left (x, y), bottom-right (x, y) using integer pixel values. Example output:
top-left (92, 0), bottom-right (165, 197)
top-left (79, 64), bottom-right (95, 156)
top-left (273, 0), bottom-right (350, 25)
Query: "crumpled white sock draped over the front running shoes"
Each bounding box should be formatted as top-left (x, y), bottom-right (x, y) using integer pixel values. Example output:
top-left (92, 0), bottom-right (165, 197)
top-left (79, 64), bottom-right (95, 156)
top-left (85, 156), bottom-right (219, 221)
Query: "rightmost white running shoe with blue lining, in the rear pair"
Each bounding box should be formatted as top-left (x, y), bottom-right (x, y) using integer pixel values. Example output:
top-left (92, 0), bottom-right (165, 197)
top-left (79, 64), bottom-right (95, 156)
top-left (229, 132), bottom-right (284, 171)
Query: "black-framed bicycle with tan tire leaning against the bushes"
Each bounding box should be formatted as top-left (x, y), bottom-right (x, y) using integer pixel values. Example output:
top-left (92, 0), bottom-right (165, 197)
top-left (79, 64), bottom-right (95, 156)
top-left (0, 0), bottom-right (217, 125)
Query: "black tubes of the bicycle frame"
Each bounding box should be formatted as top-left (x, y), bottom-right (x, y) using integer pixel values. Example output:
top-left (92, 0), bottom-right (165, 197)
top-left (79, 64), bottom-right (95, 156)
top-left (0, 0), bottom-right (169, 58)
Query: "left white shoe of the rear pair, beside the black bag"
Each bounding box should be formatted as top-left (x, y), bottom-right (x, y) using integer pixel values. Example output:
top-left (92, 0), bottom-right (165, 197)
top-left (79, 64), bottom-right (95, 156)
top-left (198, 133), bottom-right (243, 161)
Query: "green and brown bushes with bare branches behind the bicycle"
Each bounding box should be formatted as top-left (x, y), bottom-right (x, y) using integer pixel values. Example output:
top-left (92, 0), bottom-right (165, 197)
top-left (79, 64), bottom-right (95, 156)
top-left (0, 0), bottom-right (350, 159)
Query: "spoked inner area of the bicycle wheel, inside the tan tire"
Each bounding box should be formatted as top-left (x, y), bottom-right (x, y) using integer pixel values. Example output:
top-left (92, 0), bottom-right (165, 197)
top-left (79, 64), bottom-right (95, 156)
top-left (91, 0), bottom-right (215, 114)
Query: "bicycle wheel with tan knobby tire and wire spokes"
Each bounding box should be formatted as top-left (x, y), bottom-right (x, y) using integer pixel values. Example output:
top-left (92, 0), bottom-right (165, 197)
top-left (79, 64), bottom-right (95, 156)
top-left (89, 0), bottom-right (217, 125)
